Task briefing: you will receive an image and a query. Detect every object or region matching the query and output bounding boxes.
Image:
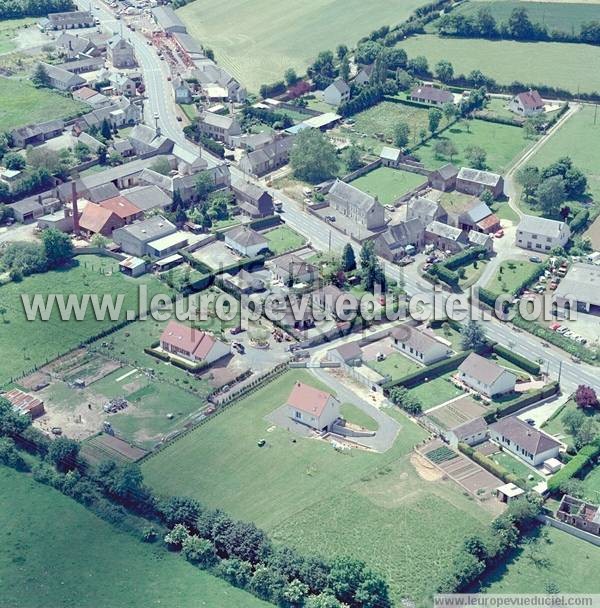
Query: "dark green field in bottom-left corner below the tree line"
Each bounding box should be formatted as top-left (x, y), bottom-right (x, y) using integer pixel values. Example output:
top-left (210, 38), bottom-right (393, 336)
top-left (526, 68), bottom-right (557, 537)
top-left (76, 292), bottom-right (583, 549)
top-left (0, 467), bottom-right (269, 608)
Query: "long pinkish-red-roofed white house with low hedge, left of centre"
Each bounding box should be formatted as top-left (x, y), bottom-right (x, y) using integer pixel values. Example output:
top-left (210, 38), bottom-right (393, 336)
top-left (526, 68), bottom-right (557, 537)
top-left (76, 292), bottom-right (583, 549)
top-left (160, 321), bottom-right (230, 365)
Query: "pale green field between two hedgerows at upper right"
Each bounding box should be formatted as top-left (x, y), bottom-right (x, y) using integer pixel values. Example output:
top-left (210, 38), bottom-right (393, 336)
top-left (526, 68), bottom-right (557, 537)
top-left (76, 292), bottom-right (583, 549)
top-left (400, 34), bottom-right (600, 93)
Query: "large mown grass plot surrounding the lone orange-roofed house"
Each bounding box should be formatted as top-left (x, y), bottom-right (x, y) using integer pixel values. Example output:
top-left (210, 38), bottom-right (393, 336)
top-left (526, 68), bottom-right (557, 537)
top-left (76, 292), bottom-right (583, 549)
top-left (142, 370), bottom-right (490, 600)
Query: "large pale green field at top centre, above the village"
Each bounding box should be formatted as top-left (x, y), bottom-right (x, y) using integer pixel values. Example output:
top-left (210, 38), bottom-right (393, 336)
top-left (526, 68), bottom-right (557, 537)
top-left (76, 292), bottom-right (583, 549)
top-left (177, 0), bottom-right (424, 92)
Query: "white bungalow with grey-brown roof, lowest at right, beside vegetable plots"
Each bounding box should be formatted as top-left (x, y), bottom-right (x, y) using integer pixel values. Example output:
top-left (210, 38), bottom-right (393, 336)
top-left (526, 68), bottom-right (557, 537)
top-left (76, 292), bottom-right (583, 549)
top-left (489, 416), bottom-right (560, 467)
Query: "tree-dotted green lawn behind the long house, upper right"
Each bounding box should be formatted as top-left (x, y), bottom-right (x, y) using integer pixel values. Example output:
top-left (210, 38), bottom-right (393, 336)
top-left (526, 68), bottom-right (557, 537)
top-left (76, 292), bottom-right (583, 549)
top-left (414, 119), bottom-right (531, 173)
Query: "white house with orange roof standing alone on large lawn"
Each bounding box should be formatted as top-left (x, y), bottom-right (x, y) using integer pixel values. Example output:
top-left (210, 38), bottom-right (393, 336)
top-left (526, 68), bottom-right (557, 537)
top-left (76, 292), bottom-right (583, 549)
top-left (286, 382), bottom-right (340, 432)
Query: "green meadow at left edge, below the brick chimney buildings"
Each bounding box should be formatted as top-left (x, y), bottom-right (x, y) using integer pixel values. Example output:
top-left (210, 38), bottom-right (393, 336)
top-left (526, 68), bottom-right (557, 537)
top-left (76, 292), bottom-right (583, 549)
top-left (0, 255), bottom-right (165, 382)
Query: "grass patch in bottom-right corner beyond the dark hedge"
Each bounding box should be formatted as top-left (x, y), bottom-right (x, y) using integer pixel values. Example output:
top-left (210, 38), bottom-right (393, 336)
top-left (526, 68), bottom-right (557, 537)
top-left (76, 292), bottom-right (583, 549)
top-left (479, 526), bottom-right (600, 593)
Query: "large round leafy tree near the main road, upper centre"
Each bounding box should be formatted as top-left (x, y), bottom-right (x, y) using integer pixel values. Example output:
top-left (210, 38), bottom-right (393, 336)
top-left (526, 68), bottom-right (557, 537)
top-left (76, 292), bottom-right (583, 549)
top-left (290, 129), bottom-right (339, 184)
